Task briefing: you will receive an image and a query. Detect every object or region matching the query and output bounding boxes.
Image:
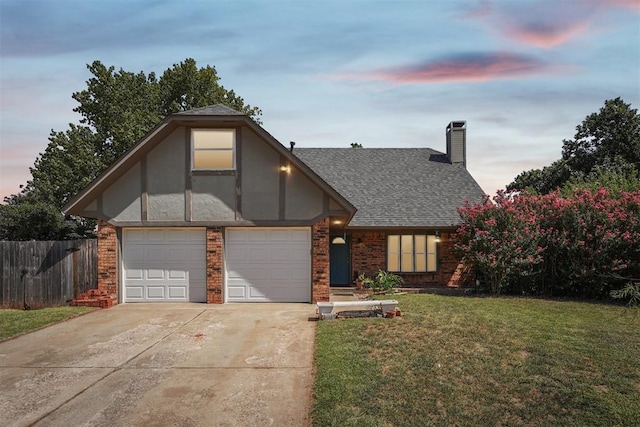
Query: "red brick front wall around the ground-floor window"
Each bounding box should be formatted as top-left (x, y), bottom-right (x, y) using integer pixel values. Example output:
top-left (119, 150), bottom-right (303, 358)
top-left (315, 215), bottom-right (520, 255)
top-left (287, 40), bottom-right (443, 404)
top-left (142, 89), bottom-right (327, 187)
top-left (351, 231), bottom-right (472, 287)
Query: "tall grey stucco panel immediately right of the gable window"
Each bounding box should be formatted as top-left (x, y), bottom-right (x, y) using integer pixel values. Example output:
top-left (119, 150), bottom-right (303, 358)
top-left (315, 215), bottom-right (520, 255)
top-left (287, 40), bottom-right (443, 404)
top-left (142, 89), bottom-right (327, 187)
top-left (241, 128), bottom-right (282, 220)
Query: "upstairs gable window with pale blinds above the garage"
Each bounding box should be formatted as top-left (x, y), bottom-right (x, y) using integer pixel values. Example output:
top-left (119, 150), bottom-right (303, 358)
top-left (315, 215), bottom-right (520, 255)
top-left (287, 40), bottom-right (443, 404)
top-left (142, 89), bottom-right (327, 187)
top-left (191, 129), bottom-right (236, 170)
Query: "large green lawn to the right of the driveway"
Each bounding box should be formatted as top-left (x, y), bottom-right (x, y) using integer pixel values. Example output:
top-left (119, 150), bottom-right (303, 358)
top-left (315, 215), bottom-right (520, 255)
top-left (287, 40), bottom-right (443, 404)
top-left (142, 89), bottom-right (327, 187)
top-left (312, 294), bottom-right (640, 426)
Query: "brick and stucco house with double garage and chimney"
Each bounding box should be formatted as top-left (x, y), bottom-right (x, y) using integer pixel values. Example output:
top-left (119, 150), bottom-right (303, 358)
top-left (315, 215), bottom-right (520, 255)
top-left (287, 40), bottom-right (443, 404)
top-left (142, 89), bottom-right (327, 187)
top-left (64, 105), bottom-right (484, 303)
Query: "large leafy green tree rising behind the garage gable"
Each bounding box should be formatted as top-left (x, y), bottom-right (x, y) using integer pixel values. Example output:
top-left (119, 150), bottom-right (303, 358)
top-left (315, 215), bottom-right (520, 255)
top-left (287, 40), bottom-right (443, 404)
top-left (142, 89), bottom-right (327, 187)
top-left (72, 58), bottom-right (262, 168)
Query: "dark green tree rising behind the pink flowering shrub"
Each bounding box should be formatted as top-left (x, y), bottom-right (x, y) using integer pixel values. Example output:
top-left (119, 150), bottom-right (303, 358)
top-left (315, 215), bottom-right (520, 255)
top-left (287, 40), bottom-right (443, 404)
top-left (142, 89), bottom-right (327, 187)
top-left (507, 98), bottom-right (640, 194)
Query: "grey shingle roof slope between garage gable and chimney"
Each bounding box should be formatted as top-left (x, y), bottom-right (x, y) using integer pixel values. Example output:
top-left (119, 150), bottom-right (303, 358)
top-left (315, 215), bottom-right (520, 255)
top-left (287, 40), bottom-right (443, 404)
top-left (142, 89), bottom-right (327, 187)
top-left (293, 148), bottom-right (485, 227)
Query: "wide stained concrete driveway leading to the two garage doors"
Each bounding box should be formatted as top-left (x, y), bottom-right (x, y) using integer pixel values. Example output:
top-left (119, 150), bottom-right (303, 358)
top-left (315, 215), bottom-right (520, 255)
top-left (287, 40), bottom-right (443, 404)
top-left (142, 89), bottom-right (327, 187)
top-left (0, 304), bottom-right (315, 427)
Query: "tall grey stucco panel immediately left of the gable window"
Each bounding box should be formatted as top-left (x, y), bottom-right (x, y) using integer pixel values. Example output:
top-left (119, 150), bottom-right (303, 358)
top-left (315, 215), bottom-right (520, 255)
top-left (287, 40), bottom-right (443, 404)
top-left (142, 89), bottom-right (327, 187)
top-left (147, 128), bottom-right (188, 221)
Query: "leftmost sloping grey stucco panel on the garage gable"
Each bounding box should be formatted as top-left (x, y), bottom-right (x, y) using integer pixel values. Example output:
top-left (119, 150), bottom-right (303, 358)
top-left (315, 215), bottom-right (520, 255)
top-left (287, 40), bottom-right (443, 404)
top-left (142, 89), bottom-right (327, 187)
top-left (102, 163), bottom-right (142, 221)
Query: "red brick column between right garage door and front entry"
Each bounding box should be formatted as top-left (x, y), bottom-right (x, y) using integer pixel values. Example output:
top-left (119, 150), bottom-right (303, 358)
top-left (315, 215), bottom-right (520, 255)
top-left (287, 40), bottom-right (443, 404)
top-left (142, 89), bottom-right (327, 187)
top-left (311, 218), bottom-right (329, 303)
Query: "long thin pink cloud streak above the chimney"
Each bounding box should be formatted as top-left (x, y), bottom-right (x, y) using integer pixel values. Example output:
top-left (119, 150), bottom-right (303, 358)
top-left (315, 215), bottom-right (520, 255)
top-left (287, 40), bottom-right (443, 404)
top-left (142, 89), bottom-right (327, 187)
top-left (335, 52), bottom-right (552, 84)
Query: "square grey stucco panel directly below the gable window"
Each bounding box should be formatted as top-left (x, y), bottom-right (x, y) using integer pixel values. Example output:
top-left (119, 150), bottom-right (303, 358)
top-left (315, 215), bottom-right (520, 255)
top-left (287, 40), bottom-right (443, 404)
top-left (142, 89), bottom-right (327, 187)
top-left (191, 175), bottom-right (236, 221)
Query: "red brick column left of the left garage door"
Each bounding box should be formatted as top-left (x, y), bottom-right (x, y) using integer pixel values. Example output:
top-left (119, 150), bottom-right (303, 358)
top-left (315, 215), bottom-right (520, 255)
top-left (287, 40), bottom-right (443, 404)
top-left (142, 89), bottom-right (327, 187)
top-left (98, 220), bottom-right (118, 301)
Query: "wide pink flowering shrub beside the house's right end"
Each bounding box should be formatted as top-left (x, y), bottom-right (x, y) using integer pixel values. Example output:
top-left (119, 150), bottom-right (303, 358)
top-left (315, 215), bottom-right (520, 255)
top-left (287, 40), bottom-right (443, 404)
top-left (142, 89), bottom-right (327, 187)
top-left (454, 189), bottom-right (640, 297)
